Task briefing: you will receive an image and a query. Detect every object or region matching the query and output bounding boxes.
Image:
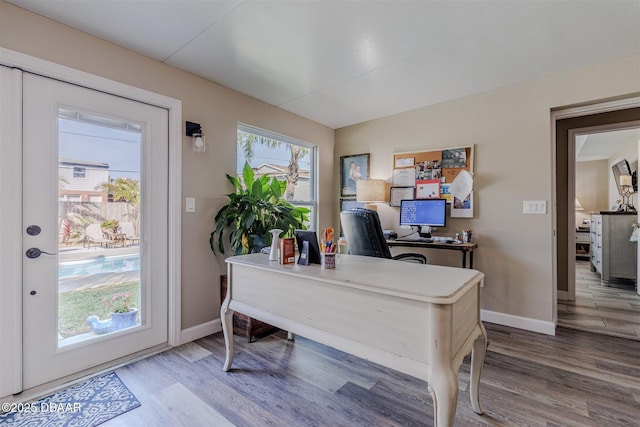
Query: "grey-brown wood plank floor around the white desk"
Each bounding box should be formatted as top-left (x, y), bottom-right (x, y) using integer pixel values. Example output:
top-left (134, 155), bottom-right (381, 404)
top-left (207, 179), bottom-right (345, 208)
top-left (104, 324), bottom-right (640, 427)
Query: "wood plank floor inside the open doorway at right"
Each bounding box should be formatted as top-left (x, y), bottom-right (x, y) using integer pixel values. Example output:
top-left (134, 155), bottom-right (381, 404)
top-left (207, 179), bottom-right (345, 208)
top-left (558, 260), bottom-right (640, 340)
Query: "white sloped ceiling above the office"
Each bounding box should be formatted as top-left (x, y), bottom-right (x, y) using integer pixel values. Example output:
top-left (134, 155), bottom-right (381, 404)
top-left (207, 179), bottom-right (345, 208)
top-left (6, 0), bottom-right (640, 128)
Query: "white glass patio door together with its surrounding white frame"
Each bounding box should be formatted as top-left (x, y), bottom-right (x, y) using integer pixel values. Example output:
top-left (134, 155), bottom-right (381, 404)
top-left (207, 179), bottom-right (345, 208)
top-left (0, 48), bottom-right (182, 397)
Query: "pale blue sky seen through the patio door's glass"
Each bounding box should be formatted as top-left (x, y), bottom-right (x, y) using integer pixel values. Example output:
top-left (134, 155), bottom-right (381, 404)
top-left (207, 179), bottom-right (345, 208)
top-left (58, 118), bottom-right (142, 181)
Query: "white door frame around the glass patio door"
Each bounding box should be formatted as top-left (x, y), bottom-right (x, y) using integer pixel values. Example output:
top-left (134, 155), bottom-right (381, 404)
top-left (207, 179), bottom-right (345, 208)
top-left (0, 47), bottom-right (182, 397)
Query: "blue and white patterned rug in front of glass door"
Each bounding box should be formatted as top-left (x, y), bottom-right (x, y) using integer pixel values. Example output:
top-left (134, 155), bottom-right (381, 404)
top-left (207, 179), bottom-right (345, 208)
top-left (0, 372), bottom-right (140, 427)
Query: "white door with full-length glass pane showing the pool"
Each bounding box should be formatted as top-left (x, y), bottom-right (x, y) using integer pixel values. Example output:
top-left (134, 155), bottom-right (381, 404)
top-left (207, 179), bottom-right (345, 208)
top-left (22, 73), bottom-right (169, 389)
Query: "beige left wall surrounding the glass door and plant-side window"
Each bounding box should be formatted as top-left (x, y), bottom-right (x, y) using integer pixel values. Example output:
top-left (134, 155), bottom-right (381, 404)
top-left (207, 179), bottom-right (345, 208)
top-left (0, 1), bottom-right (334, 329)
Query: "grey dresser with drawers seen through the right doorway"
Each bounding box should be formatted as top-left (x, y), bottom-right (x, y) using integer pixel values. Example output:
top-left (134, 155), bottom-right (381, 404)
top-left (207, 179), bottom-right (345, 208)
top-left (590, 212), bottom-right (638, 286)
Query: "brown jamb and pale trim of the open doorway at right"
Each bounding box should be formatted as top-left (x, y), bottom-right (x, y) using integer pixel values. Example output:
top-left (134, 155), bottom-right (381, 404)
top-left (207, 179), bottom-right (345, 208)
top-left (554, 98), bottom-right (640, 342)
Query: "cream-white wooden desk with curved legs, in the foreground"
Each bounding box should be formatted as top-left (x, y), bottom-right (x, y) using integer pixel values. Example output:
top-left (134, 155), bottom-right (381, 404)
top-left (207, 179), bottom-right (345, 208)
top-left (220, 254), bottom-right (487, 427)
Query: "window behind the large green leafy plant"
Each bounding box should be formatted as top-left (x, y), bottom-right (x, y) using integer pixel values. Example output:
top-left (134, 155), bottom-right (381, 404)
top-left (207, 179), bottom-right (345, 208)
top-left (236, 124), bottom-right (316, 228)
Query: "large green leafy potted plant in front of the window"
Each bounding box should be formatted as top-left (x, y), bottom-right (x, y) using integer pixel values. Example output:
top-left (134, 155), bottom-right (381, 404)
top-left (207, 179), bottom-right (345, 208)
top-left (209, 163), bottom-right (310, 254)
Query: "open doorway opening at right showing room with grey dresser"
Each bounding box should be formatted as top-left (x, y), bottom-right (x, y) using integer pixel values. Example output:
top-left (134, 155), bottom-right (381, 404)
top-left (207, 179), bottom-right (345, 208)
top-left (558, 123), bottom-right (640, 340)
